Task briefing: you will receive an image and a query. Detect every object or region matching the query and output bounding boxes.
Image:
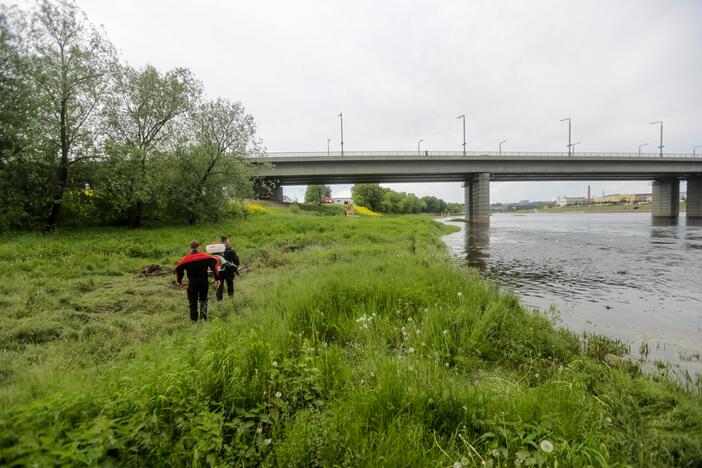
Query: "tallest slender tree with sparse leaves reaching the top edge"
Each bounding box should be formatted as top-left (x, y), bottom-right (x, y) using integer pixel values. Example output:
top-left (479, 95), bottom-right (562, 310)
top-left (28, 0), bottom-right (115, 227)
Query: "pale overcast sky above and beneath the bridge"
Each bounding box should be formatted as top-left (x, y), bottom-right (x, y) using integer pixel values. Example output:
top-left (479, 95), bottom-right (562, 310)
top-left (11, 0), bottom-right (702, 202)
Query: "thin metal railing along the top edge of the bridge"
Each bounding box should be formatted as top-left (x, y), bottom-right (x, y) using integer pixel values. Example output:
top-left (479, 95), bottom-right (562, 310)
top-left (267, 151), bottom-right (702, 159)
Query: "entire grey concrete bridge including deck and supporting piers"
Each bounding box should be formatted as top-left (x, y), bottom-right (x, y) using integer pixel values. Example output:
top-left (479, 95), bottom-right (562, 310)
top-left (253, 151), bottom-right (702, 223)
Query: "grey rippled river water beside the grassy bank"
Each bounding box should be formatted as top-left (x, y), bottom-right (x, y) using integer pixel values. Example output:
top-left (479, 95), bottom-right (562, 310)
top-left (440, 213), bottom-right (702, 376)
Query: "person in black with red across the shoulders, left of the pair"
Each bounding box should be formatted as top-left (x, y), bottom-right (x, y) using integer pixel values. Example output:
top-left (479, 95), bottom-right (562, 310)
top-left (175, 241), bottom-right (220, 322)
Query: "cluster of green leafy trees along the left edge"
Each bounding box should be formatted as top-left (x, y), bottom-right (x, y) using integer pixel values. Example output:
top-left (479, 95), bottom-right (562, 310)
top-left (0, 0), bottom-right (263, 231)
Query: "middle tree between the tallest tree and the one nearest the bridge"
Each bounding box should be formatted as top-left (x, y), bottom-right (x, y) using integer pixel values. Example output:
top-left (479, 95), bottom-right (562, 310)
top-left (99, 65), bottom-right (201, 227)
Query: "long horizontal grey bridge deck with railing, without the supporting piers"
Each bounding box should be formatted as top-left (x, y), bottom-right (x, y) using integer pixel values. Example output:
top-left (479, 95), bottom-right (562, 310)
top-left (253, 152), bottom-right (702, 185)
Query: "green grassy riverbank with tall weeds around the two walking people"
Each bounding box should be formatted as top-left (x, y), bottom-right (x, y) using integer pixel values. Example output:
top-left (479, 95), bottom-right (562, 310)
top-left (0, 209), bottom-right (702, 466)
